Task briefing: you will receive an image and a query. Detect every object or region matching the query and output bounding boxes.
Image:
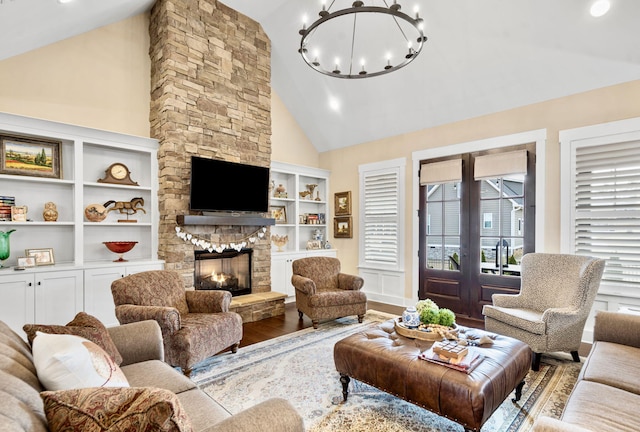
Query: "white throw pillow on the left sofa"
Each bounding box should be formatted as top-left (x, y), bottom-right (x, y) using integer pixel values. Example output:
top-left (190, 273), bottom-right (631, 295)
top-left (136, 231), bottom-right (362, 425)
top-left (32, 332), bottom-right (129, 390)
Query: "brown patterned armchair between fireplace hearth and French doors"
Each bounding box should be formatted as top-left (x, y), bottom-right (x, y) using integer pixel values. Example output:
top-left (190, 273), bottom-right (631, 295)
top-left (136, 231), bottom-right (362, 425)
top-left (291, 257), bottom-right (367, 329)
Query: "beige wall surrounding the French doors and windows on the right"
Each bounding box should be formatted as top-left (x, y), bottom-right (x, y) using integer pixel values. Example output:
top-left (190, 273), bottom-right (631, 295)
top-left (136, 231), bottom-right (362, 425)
top-left (320, 81), bottom-right (640, 298)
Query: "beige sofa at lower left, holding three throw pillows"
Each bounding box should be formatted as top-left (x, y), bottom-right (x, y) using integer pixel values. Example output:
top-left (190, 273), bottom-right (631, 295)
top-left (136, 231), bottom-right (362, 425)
top-left (0, 321), bottom-right (304, 432)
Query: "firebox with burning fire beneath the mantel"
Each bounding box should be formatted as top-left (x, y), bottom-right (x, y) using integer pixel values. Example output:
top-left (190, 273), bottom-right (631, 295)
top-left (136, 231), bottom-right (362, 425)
top-left (194, 249), bottom-right (253, 296)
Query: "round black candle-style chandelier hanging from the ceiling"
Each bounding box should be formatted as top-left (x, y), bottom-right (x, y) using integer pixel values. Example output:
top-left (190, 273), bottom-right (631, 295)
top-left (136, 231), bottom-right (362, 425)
top-left (298, 0), bottom-right (427, 78)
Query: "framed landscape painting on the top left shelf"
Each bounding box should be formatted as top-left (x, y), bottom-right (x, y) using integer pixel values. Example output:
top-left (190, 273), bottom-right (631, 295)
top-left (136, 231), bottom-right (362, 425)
top-left (0, 136), bottom-right (62, 178)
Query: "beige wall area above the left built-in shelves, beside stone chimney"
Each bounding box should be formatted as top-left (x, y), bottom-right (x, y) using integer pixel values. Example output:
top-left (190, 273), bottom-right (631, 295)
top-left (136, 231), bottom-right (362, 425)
top-left (0, 14), bottom-right (150, 137)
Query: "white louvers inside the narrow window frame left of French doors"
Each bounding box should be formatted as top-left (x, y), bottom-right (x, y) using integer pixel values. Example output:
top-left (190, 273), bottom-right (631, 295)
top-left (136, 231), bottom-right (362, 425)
top-left (362, 168), bottom-right (400, 266)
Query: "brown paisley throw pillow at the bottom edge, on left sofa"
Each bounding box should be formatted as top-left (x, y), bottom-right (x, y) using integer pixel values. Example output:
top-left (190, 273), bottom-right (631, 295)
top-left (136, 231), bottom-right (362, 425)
top-left (40, 387), bottom-right (191, 432)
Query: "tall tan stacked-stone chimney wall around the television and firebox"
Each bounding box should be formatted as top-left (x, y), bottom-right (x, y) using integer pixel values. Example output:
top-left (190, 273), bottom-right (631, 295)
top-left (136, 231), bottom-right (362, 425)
top-left (149, 0), bottom-right (271, 292)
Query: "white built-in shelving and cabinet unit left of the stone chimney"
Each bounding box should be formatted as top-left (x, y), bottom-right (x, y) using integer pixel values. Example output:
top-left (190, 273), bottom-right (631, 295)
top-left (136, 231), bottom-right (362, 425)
top-left (0, 113), bottom-right (163, 329)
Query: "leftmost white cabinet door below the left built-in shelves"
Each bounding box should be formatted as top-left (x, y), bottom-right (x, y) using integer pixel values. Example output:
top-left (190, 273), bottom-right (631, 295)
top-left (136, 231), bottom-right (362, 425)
top-left (0, 270), bottom-right (35, 337)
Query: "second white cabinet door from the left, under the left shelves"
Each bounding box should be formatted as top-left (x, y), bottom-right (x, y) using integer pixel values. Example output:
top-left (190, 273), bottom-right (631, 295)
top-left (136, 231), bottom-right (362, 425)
top-left (32, 270), bottom-right (84, 325)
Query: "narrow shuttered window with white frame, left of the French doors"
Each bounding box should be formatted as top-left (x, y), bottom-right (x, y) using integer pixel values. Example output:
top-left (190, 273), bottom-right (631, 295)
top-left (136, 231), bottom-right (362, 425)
top-left (359, 159), bottom-right (405, 270)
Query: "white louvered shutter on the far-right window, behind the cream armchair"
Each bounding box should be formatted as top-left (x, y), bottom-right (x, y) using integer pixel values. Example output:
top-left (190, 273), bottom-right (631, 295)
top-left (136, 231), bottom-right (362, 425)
top-left (573, 141), bottom-right (640, 288)
